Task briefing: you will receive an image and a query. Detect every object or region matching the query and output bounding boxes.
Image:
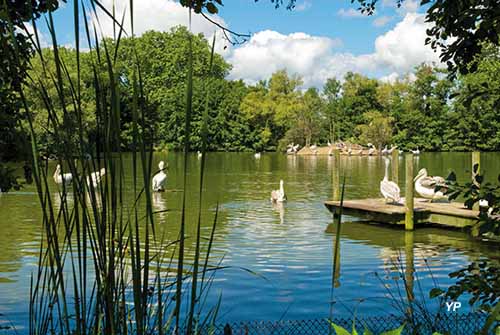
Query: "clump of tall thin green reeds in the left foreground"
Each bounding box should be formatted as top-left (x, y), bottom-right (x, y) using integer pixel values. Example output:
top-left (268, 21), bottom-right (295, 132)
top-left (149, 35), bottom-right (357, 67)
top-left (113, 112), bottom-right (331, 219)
top-left (8, 0), bottom-right (220, 335)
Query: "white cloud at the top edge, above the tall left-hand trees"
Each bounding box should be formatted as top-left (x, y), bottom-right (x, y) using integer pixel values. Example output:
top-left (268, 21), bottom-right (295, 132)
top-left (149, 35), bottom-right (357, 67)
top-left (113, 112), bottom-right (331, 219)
top-left (92, 0), bottom-right (229, 55)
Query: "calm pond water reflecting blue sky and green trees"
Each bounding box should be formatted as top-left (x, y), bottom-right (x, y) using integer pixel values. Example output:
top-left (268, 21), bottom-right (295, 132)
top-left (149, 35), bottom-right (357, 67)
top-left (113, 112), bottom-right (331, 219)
top-left (0, 153), bottom-right (500, 329)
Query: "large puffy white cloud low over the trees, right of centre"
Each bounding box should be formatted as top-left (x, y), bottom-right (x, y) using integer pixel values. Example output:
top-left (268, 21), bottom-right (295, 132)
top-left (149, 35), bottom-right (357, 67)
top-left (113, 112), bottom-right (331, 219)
top-left (227, 13), bottom-right (439, 87)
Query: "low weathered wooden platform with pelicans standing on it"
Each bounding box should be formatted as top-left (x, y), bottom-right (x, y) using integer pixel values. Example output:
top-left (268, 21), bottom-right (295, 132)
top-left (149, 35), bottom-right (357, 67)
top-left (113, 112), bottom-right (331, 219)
top-left (325, 198), bottom-right (479, 228)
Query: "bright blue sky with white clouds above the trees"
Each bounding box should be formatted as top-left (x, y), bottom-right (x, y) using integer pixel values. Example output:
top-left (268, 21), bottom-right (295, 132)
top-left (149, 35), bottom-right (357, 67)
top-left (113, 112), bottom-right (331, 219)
top-left (39, 0), bottom-right (439, 88)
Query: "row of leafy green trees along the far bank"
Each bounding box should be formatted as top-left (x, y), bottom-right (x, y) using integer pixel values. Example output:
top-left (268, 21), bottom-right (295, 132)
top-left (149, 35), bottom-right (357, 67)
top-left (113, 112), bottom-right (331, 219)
top-left (0, 27), bottom-right (500, 159)
